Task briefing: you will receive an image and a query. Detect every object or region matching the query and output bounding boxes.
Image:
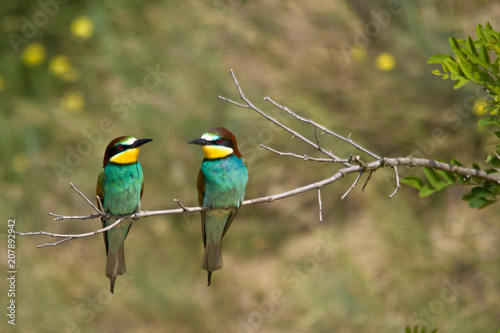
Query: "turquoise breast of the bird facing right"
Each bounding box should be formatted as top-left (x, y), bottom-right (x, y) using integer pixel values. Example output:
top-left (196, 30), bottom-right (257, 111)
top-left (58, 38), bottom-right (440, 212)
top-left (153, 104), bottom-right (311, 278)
top-left (103, 163), bottom-right (144, 215)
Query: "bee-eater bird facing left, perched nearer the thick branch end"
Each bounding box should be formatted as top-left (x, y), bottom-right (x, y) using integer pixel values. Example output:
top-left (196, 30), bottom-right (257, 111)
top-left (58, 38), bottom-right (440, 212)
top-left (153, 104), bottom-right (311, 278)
top-left (188, 127), bottom-right (248, 285)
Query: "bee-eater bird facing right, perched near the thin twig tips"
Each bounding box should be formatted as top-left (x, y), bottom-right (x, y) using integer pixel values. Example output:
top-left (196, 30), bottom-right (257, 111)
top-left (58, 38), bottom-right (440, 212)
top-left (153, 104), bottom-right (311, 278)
top-left (96, 136), bottom-right (153, 293)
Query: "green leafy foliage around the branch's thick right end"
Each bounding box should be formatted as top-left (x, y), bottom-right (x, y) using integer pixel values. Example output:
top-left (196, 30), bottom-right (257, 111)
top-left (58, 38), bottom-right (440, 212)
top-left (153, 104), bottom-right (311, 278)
top-left (401, 22), bottom-right (500, 208)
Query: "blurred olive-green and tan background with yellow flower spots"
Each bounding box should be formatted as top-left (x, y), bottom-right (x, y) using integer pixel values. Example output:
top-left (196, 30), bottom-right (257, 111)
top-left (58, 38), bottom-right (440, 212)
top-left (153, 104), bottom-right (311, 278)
top-left (0, 0), bottom-right (500, 333)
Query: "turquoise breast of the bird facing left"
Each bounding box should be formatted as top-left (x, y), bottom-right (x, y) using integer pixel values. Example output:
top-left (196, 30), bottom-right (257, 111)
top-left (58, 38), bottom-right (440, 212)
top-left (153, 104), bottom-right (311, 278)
top-left (201, 155), bottom-right (248, 208)
